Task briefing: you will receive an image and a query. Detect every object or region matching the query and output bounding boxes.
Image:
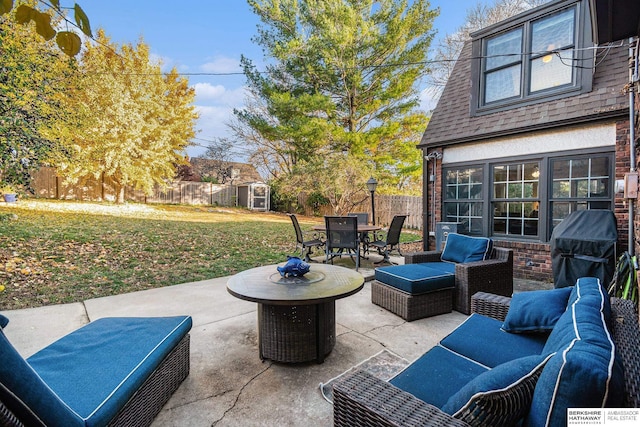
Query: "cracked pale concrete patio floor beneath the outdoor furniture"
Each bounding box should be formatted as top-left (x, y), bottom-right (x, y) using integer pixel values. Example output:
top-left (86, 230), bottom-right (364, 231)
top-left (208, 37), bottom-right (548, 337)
top-left (3, 256), bottom-right (546, 427)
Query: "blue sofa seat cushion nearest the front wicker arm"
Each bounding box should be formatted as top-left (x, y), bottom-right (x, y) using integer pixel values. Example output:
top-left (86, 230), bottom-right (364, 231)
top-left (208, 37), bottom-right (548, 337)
top-left (389, 346), bottom-right (488, 408)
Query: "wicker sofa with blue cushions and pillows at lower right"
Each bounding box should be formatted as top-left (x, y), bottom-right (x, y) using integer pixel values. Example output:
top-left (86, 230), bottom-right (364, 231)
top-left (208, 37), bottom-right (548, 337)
top-left (334, 278), bottom-right (640, 426)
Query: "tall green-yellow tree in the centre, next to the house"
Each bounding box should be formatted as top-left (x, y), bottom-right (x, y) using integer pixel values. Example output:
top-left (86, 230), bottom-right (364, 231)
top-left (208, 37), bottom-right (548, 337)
top-left (231, 0), bottom-right (437, 197)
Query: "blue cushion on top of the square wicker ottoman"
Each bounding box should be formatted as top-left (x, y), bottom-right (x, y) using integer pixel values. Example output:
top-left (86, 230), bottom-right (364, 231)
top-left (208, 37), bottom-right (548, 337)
top-left (375, 262), bottom-right (456, 295)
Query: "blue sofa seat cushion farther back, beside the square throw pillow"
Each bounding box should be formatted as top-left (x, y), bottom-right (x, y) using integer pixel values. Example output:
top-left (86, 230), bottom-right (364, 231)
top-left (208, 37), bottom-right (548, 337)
top-left (440, 313), bottom-right (546, 368)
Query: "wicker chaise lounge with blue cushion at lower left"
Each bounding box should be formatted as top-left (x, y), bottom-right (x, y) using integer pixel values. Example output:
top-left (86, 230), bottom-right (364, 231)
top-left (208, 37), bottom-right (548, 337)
top-left (0, 315), bottom-right (192, 427)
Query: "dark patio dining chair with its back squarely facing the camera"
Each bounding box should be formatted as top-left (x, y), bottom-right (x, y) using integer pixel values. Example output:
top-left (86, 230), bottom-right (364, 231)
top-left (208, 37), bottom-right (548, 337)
top-left (324, 216), bottom-right (360, 271)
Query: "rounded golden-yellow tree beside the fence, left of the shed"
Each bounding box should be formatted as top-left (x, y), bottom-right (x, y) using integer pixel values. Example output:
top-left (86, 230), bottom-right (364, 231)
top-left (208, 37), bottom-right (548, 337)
top-left (60, 31), bottom-right (197, 202)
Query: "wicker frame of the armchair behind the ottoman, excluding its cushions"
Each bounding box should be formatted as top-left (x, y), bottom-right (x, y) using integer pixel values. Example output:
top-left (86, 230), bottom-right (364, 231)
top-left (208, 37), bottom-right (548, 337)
top-left (404, 247), bottom-right (513, 314)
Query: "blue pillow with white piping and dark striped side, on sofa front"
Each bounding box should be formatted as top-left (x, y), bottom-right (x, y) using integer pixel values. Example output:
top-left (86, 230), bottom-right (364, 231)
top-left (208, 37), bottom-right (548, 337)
top-left (442, 355), bottom-right (552, 426)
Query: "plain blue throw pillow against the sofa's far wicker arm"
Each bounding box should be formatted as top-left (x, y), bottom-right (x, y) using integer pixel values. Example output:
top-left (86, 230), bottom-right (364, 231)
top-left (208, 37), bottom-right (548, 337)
top-left (502, 287), bottom-right (573, 333)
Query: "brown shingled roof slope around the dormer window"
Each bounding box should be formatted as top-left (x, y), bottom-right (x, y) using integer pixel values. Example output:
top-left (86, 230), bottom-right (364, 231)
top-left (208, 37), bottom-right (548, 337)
top-left (418, 41), bottom-right (629, 148)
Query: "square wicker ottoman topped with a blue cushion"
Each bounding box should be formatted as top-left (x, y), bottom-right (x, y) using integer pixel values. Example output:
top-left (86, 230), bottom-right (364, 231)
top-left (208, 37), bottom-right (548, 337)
top-left (371, 263), bottom-right (455, 321)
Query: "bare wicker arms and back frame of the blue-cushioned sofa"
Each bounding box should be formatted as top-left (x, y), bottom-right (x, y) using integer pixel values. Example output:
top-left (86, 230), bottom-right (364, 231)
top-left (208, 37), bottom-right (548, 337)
top-left (333, 292), bottom-right (640, 427)
